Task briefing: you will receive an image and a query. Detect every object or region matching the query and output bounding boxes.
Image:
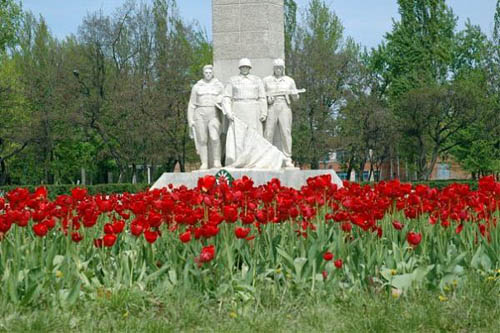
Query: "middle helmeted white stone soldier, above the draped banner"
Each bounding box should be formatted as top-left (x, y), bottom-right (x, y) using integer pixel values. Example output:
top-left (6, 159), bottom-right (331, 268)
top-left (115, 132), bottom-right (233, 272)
top-left (224, 58), bottom-right (267, 135)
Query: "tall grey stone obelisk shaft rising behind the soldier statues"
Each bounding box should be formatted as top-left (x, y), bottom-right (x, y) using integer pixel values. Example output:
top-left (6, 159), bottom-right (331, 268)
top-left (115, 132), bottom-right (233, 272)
top-left (212, 0), bottom-right (285, 83)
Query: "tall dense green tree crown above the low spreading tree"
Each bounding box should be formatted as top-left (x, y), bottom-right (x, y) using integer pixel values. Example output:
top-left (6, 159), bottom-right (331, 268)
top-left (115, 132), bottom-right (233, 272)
top-left (374, 0), bottom-right (457, 101)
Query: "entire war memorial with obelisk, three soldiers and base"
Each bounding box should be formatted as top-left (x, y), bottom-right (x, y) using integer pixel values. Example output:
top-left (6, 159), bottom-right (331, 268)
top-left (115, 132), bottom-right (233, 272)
top-left (152, 0), bottom-right (342, 189)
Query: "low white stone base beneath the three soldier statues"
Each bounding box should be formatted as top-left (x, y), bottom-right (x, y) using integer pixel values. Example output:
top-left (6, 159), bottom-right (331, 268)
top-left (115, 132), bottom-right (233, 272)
top-left (151, 168), bottom-right (342, 190)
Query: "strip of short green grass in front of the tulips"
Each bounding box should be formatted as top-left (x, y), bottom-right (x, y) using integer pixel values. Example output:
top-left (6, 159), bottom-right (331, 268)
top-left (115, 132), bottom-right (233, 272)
top-left (0, 275), bottom-right (500, 332)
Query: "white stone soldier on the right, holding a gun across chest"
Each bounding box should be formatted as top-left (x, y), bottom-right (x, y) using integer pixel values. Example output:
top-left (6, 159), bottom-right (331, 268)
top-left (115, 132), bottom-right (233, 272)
top-left (264, 59), bottom-right (305, 168)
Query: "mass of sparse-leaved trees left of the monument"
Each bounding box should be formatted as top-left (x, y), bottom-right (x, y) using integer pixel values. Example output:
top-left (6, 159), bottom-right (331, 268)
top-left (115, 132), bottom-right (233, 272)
top-left (0, 0), bottom-right (212, 184)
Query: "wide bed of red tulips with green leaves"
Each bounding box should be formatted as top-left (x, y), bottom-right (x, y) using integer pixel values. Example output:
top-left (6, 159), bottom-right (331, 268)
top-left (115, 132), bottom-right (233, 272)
top-left (0, 176), bottom-right (500, 304)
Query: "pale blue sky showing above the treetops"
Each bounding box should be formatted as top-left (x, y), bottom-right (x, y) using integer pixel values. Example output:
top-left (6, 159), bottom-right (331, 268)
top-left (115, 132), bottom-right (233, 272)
top-left (22, 0), bottom-right (497, 48)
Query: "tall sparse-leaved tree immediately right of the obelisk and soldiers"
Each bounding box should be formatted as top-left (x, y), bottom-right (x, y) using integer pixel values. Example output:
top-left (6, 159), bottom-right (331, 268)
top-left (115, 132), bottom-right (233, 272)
top-left (291, 0), bottom-right (358, 169)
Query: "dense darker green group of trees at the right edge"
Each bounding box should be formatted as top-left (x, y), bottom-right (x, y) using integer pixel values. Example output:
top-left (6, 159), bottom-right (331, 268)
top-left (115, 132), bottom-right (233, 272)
top-left (368, 0), bottom-right (500, 179)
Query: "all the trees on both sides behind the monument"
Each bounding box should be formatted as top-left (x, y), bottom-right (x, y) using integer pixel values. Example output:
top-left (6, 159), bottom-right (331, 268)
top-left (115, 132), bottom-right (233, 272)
top-left (0, 0), bottom-right (500, 184)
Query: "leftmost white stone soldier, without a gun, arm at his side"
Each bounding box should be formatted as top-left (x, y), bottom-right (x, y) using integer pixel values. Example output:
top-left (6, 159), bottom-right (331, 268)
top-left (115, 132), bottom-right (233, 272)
top-left (188, 65), bottom-right (224, 170)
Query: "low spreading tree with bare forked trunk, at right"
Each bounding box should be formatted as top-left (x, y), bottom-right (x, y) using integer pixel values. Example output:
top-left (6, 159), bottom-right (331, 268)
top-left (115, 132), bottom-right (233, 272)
top-left (396, 80), bottom-right (488, 179)
